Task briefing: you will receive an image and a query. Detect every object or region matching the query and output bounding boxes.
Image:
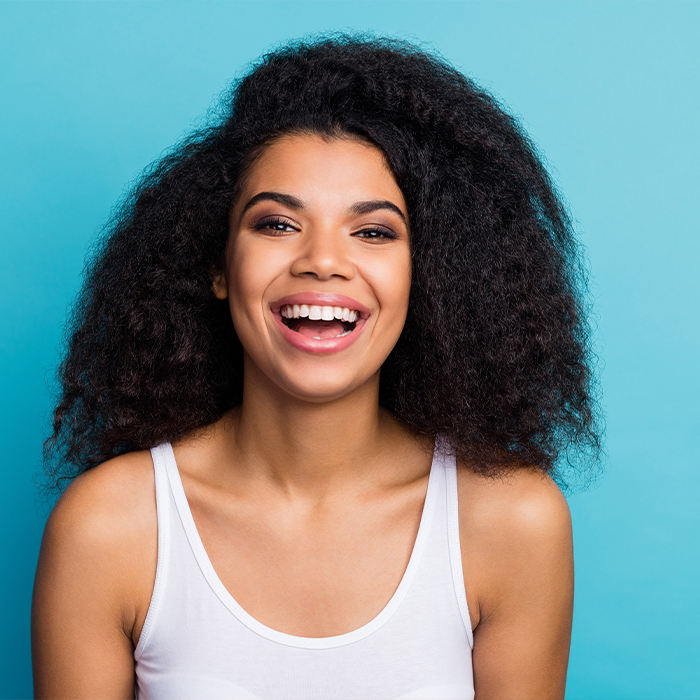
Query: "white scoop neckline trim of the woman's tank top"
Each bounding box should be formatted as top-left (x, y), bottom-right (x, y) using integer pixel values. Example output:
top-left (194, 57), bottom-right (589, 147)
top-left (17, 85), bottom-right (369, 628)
top-left (163, 443), bottom-right (440, 649)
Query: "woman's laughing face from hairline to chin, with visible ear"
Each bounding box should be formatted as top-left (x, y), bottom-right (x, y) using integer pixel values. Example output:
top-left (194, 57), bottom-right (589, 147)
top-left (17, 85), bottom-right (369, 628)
top-left (214, 134), bottom-right (411, 401)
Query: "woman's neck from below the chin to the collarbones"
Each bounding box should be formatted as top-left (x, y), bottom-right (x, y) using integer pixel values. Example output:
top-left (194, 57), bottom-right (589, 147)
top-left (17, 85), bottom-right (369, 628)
top-left (232, 356), bottom-right (404, 498)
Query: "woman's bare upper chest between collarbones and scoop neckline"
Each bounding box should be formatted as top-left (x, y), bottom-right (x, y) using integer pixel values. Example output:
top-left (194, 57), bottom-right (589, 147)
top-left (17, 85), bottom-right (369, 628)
top-left (185, 480), bottom-right (427, 637)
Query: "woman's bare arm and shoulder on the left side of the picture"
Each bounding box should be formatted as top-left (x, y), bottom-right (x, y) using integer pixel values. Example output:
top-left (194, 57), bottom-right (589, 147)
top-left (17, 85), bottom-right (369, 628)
top-left (32, 459), bottom-right (157, 698)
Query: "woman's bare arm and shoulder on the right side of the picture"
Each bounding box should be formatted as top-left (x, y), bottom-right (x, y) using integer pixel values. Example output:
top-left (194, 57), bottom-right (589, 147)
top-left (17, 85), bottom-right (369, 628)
top-left (460, 471), bottom-right (574, 700)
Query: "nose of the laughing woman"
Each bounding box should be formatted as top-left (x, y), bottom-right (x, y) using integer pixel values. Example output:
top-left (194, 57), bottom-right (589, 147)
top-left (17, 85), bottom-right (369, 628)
top-left (291, 226), bottom-right (355, 280)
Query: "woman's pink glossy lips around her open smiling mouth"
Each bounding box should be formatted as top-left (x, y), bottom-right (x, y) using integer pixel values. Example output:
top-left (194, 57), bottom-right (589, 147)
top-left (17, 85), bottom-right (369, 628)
top-left (270, 292), bottom-right (372, 354)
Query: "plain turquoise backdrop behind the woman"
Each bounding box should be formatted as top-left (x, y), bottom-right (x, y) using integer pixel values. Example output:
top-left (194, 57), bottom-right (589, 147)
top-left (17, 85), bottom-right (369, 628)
top-left (0, 2), bottom-right (700, 700)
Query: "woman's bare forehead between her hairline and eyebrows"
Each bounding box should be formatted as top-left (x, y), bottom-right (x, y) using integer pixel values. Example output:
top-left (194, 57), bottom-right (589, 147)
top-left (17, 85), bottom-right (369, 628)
top-left (240, 134), bottom-right (406, 213)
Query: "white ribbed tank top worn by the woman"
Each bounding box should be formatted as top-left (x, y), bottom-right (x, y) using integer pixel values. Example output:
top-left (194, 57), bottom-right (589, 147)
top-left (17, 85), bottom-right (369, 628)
top-left (134, 443), bottom-right (474, 700)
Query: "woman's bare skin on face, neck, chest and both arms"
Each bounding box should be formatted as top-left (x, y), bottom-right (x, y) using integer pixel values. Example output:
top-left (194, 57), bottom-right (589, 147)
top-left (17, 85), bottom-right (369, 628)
top-left (32, 135), bottom-right (573, 700)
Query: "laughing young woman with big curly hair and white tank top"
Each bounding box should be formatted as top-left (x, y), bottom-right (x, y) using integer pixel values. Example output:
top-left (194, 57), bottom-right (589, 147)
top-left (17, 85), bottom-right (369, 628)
top-left (33, 37), bottom-right (598, 700)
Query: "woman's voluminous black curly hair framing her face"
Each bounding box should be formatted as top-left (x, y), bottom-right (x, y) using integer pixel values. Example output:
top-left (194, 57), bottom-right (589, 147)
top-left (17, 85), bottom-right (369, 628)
top-left (45, 35), bottom-right (601, 489)
